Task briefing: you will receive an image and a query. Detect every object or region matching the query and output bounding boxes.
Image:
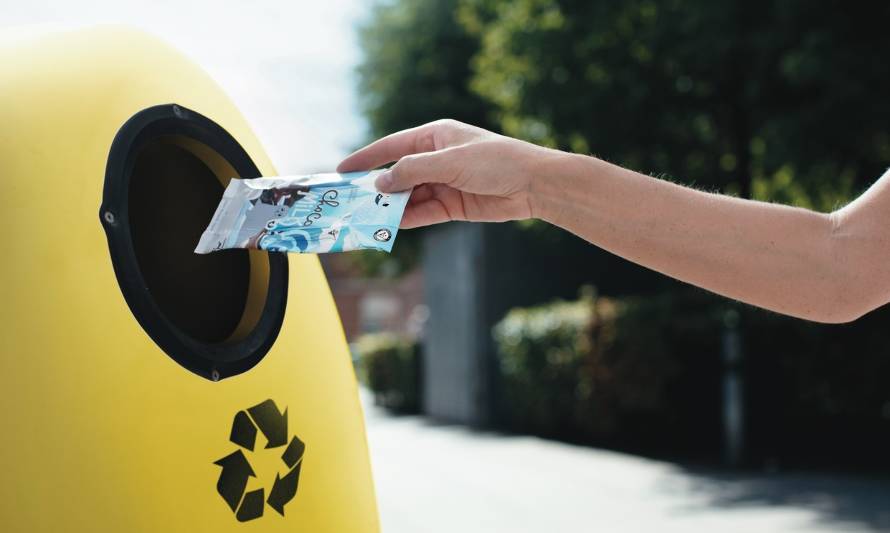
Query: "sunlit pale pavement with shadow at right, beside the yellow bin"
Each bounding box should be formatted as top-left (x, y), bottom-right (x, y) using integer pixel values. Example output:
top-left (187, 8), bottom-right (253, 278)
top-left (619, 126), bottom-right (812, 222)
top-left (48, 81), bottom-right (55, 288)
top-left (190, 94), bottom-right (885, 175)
top-left (364, 390), bottom-right (890, 533)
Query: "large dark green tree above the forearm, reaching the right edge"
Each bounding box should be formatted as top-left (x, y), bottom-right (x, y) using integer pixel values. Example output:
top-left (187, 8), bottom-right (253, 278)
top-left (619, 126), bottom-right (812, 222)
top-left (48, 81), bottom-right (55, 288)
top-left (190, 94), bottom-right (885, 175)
top-left (460, 0), bottom-right (890, 208)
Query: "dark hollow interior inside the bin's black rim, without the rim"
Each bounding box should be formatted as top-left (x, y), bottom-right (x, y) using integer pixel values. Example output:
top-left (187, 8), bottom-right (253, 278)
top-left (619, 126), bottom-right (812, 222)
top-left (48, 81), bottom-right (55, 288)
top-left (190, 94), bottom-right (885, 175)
top-left (128, 138), bottom-right (250, 343)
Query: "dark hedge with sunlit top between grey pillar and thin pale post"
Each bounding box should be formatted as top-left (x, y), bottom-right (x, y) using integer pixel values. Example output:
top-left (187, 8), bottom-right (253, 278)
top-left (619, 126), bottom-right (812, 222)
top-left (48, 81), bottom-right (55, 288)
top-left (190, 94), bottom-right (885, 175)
top-left (494, 290), bottom-right (719, 447)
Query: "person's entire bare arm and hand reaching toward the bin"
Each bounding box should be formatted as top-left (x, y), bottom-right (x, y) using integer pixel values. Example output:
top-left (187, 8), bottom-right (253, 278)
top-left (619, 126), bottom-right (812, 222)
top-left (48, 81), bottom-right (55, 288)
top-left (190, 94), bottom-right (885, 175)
top-left (340, 121), bottom-right (890, 322)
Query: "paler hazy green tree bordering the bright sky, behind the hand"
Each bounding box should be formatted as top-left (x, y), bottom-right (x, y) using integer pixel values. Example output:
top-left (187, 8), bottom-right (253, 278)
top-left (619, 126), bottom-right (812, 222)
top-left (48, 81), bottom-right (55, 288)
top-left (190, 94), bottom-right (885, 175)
top-left (352, 0), bottom-right (495, 275)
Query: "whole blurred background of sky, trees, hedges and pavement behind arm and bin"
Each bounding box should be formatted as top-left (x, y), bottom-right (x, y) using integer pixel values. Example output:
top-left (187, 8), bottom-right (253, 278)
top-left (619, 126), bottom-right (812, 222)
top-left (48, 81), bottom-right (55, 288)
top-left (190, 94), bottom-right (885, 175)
top-left (6, 0), bottom-right (890, 533)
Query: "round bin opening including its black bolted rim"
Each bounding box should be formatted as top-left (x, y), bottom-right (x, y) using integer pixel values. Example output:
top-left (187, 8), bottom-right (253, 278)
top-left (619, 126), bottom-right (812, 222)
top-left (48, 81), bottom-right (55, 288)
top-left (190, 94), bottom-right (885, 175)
top-left (100, 105), bottom-right (287, 381)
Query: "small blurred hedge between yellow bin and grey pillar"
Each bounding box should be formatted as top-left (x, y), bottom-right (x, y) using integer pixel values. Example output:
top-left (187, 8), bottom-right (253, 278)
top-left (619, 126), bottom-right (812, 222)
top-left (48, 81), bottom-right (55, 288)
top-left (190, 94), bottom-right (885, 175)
top-left (355, 333), bottom-right (422, 413)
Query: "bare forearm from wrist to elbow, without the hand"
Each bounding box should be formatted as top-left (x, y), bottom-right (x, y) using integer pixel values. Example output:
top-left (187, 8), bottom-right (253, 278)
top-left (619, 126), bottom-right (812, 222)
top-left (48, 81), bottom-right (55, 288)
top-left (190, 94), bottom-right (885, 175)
top-left (533, 155), bottom-right (861, 322)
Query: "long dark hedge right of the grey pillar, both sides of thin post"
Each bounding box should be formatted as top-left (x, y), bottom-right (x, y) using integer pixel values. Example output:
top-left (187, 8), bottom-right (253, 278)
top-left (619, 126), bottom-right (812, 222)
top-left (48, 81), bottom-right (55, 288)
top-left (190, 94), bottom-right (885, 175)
top-left (493, 288), bottom-right (890, 465)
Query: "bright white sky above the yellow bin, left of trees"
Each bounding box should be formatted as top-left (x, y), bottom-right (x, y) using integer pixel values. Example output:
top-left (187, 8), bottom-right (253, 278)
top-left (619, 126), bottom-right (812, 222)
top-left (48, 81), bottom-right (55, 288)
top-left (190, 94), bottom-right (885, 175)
top-left (0, 0), bottom-right (370, 174)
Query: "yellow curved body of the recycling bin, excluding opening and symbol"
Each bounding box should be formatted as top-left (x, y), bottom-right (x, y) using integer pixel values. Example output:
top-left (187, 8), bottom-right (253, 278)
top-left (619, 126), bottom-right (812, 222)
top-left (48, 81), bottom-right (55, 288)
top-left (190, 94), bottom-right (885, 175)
top-left (0, 28), bottom-right (378, 533)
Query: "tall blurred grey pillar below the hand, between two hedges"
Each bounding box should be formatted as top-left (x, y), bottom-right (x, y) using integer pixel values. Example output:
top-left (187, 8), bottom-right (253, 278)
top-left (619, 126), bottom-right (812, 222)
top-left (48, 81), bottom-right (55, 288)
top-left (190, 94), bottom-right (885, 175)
top-left (423, 222), bottom-right (534, 426)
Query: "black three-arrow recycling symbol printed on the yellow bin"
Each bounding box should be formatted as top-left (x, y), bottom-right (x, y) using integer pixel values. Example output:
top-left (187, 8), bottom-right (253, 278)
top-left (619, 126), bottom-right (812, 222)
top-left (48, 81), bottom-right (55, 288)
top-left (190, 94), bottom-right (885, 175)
top-left (213, 400), bottom-right (306, 522)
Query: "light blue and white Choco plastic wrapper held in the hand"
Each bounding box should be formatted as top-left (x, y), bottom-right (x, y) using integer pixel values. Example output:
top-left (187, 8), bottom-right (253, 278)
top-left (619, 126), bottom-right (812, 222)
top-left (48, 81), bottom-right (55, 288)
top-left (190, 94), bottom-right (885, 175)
top-left (195, 170), bottom-right (410, 254)
